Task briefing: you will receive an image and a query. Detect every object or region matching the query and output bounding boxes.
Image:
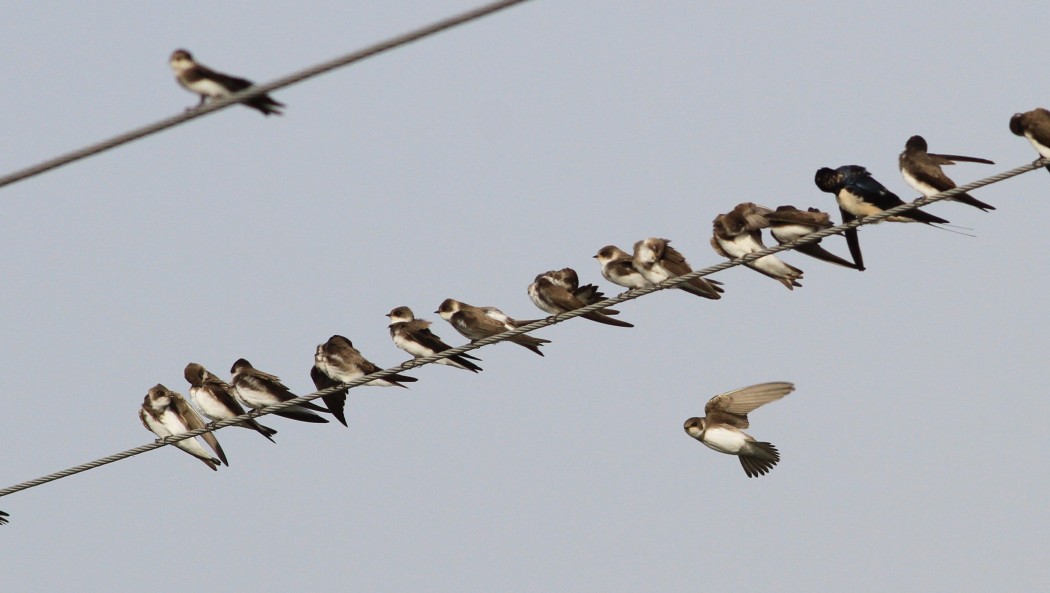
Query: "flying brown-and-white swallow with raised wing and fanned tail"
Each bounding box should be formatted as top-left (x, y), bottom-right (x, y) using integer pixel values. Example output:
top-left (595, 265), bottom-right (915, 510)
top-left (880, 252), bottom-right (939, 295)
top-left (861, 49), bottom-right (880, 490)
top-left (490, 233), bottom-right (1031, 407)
top-left (684, 383), bottom-right (795, 478)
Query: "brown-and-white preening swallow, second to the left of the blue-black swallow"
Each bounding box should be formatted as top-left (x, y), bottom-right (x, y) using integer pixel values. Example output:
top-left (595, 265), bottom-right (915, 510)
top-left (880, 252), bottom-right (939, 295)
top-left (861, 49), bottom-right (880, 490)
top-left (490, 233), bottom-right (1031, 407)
top-left (711, 202), bottom-right (802, 291)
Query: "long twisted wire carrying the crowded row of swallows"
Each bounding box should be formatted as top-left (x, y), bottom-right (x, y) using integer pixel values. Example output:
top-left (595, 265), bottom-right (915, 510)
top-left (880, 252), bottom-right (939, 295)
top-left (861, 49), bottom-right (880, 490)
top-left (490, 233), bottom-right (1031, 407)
top-left (0, 158), bottom-right (1050, 497)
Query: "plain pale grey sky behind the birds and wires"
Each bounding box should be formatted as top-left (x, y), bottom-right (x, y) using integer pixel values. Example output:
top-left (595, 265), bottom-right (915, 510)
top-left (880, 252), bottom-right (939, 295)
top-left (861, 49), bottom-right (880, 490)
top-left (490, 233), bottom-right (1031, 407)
top-left (0, 1), bottom-right (1050, 592)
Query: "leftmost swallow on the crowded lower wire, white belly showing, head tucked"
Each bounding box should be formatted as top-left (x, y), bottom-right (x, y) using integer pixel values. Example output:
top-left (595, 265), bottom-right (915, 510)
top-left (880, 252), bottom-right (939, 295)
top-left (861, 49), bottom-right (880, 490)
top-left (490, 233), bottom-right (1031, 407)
top-left (139, 383), bottom-right (224, 470)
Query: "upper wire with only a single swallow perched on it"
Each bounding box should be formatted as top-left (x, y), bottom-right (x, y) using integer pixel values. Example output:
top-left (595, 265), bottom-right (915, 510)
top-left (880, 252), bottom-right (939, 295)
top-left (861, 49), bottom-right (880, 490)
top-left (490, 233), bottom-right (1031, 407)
top-left (0, 0), bottom-right (528, 188)
